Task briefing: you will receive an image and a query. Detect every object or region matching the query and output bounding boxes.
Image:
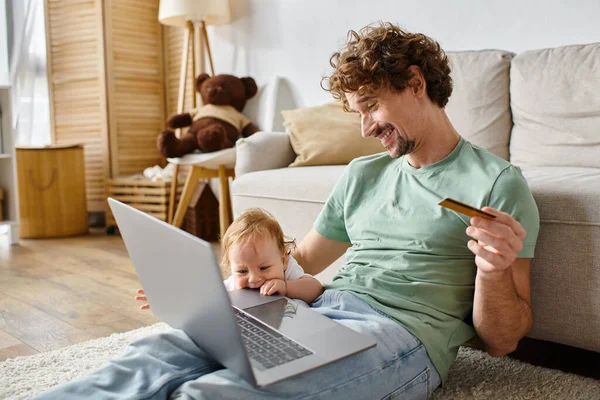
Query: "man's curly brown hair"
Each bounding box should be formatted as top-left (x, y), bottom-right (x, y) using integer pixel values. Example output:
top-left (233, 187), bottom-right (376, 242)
top-left (321, 22), bottom-right (452, 111)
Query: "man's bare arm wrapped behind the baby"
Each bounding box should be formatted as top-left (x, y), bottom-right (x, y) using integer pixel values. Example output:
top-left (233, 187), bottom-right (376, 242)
top-left (292, 228), bottom-right (352, 275)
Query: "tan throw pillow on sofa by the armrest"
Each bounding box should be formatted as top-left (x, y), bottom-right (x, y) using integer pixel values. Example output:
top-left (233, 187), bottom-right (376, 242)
top-left (281, 103), bottom-right (385, 167)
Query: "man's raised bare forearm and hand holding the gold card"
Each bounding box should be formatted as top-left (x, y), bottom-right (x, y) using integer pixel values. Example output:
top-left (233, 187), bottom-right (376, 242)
top-left (467, 207), bottom-right (532, 357)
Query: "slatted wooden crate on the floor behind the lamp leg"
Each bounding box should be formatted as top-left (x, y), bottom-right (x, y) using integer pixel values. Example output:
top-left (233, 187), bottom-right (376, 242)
top-left (106, 175), bottom-right (184, 233)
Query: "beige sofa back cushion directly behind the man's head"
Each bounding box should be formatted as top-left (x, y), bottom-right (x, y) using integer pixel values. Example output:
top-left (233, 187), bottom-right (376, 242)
top-left (446, 50), bottom-right (513, 160)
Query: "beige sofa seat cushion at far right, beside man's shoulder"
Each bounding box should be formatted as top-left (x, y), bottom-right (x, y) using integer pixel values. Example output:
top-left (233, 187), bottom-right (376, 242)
top-left (522, 167), bottom-right (600, 226)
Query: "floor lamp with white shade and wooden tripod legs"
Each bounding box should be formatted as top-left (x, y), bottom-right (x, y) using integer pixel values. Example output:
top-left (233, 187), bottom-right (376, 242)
top-left (158, 0), bottom-right (231, 223)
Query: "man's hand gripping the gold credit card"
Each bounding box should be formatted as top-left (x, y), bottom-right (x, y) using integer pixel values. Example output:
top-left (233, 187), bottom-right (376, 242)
top-left (467, 207), bottom-right (526, 275)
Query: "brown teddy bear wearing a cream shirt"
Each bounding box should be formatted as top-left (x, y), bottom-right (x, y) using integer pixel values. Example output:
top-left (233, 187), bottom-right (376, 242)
top-left (157, 74), bottom-right (258, 158)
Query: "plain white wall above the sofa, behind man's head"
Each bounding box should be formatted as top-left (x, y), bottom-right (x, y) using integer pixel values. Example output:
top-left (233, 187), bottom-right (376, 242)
top-left (209, 0), bottom-right (600, 115)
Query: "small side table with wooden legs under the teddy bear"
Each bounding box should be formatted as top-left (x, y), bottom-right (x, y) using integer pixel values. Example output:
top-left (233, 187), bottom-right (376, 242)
top-left (168, 148), bottom-right (235, 237)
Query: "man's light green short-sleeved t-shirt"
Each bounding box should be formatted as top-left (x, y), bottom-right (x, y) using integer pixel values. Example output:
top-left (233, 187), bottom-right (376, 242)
top-left (314, 138), bottom-right (539, 381)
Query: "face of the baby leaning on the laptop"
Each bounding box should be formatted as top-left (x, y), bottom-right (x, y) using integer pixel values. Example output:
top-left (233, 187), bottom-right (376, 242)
top-left (229, 236), bottom-right (287, 289)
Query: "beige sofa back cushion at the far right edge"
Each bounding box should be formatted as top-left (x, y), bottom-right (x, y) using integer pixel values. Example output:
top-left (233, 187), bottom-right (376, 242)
top-left (510, 43), bottom-right (600, 168)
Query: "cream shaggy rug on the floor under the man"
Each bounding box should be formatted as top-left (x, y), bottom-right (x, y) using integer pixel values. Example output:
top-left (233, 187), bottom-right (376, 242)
top-left (0, 323), bottom-right (600, 400)
